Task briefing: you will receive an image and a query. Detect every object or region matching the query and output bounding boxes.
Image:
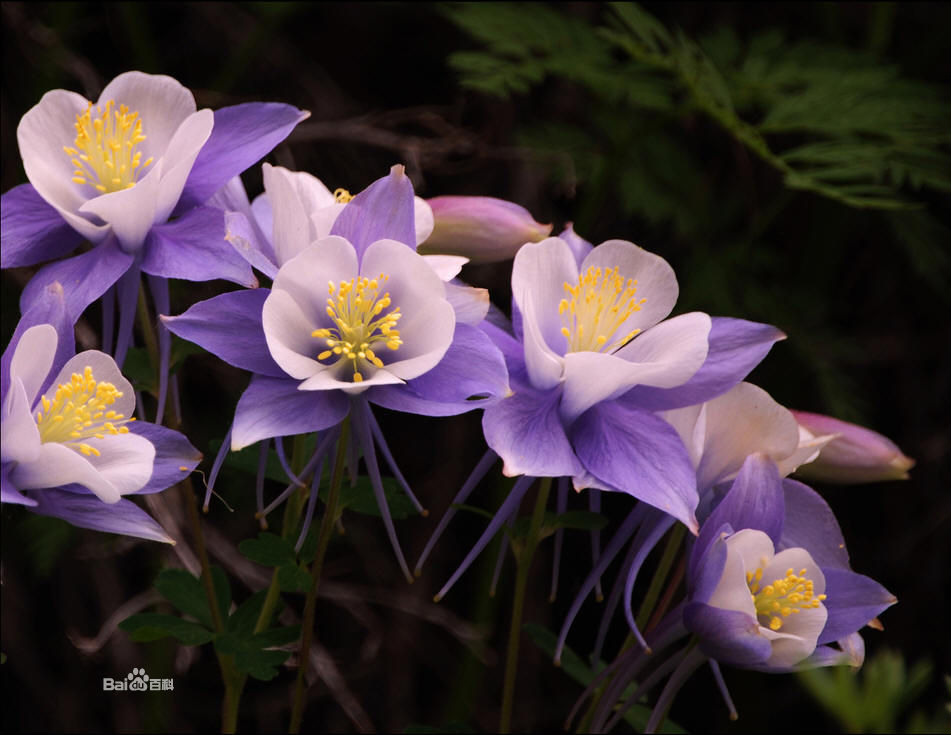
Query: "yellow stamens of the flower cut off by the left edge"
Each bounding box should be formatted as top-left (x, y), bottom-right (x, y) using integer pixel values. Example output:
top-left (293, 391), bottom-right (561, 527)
top-left (36, 365), bottom-right (135, 457)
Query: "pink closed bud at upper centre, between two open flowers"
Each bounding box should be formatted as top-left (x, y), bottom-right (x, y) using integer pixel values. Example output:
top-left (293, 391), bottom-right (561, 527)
top-left (418, 196), bottom-right (551, 263)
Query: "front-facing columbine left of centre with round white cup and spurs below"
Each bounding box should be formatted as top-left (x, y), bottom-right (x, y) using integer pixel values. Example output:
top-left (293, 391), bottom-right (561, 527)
top-left (164, 166), bottom-right (508, 575)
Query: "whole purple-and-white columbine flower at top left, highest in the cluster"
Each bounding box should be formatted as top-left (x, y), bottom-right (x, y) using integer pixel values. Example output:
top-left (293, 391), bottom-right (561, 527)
top-left (2, 72), bottom-right (308, 374)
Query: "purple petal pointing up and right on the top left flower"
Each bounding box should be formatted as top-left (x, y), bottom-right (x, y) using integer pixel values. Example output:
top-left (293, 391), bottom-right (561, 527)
top-left (175, 102), bottom-right (310, 214)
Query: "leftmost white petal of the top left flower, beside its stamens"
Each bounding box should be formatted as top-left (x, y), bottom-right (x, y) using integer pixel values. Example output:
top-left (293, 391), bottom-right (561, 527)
top-left (17, 89), bottom-right (109, 242)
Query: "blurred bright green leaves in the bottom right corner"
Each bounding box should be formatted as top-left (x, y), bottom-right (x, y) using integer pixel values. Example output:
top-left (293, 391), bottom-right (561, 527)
top-left (796, 649), bottom-right (951, 733)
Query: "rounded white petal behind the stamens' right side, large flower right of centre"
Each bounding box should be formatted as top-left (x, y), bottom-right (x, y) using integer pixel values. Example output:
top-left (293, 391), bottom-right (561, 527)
top-left (578, 240), bottom-right (679, 335)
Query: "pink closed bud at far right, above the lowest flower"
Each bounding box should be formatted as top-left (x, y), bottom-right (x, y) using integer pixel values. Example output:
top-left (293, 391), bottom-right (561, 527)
top-left (792, 411), bottom-right (915, 484)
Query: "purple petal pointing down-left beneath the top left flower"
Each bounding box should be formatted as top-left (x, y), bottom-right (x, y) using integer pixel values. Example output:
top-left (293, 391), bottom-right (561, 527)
top-left (20, 237), bottom-right (133, 323)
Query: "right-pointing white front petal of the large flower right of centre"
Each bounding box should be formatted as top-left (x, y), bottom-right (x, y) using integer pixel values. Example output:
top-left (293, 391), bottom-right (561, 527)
top-left (614, 311), bottom-right (711, 388)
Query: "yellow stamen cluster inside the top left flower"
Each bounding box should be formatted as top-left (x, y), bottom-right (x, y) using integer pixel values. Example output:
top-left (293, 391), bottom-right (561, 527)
top-left (63, 100), bottom-right (152, 194)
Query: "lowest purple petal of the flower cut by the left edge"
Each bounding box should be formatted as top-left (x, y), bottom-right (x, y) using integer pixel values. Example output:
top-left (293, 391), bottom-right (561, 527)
top-left (30, 490), bottom-right (175, 544)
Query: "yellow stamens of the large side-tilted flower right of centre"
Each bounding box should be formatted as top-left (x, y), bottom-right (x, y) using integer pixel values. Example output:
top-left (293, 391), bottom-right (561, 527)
top-left (558, 266), bottom-right (647, 352)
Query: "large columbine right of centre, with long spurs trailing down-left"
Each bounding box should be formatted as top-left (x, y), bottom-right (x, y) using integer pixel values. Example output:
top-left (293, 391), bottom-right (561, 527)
top-left (417, 229), bottom-right (783, 596)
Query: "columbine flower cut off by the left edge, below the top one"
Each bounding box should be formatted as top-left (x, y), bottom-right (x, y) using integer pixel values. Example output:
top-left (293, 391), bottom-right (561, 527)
top-left (2, 284), bottom-right (201, 542)
